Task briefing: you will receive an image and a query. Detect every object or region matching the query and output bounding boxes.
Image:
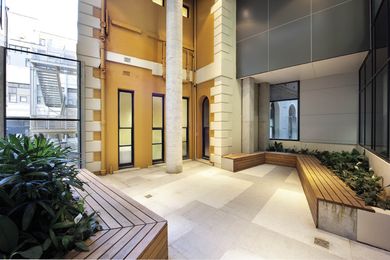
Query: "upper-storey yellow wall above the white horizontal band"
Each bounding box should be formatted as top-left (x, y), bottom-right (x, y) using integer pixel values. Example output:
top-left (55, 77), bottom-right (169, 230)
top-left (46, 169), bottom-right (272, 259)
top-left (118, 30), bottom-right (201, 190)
top-left (107, 0), bottom-right (194, 63)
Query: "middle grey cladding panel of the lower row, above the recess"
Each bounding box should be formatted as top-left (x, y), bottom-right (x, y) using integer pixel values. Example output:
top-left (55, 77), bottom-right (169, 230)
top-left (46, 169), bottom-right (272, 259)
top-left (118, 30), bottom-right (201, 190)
top-left (269, 17), bottom-right (310, 70)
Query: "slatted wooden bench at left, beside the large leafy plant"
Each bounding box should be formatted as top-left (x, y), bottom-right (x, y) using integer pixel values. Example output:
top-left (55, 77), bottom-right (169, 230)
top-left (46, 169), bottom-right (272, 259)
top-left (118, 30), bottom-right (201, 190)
top-left (65, 170), bottom-right (168, 259)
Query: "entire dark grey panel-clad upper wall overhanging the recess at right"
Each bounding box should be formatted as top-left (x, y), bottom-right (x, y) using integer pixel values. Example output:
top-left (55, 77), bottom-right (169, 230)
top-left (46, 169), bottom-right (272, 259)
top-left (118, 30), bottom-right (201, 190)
top-left (237, 0), bottom-right (370, 78)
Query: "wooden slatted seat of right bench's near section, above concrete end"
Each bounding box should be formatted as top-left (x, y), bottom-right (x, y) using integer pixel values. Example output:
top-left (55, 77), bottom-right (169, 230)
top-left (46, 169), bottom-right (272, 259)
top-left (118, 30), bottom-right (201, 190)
top-left (297, 155), bottom-right (374, 226)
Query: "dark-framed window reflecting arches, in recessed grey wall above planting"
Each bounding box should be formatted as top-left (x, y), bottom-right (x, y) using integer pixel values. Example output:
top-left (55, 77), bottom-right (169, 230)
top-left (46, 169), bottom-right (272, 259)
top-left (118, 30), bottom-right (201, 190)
top-left (270, 81), bottom-right (299, 140)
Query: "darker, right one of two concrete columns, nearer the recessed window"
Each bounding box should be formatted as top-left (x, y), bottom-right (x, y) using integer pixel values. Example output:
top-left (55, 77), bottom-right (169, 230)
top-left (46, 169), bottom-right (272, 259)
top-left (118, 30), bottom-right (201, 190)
top-left (259, 83), bottom-right (270, 151)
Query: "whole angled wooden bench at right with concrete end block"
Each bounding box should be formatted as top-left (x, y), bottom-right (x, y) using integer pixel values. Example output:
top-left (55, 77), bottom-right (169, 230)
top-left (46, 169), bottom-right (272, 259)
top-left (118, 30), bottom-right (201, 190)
top-left (222, 152), bottom-right (374, 240)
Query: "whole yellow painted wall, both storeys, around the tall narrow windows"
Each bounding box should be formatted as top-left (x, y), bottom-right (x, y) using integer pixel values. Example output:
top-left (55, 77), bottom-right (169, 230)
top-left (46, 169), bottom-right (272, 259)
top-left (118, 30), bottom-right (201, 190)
top-left (105, 0), bottom-right (195, 171)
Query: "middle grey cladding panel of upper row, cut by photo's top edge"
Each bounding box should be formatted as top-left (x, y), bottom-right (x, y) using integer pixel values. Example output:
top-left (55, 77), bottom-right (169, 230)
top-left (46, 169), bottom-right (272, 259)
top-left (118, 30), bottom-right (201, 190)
top-left (269, 0), bottom-right (310, 28)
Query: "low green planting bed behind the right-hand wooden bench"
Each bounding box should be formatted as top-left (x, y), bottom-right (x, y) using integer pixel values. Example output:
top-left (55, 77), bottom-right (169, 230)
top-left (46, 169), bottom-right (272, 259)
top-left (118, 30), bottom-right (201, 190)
top-left (267, 142), bottom-right (390, 209)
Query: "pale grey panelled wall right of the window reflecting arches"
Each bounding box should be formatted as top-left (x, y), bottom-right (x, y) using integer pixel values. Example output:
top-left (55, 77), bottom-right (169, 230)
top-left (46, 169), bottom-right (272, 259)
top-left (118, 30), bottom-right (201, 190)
top-left (300, 72), bottom-right (359, 144)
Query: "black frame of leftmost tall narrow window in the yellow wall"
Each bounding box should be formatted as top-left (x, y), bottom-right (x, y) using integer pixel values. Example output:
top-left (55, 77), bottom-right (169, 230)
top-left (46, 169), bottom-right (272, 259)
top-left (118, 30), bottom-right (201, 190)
top-left (118, 89), bottom-right (135, 169)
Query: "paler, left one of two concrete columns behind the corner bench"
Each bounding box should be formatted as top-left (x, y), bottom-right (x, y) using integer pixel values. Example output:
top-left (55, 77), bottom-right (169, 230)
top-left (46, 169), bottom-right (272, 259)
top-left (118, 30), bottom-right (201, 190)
top-left (241, 78), bottom-right (259, 153)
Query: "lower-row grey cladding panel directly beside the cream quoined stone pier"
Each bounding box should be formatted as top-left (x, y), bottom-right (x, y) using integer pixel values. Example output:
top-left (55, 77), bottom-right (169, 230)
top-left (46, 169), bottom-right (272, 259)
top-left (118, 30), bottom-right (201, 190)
top-left (237, 32), bottom-right (268, 78)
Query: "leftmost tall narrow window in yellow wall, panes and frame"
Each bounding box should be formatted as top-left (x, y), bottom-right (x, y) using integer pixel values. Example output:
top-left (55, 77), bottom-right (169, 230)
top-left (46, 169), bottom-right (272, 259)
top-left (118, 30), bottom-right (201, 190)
top-left (118, 90), bottom-right (134, 168)
